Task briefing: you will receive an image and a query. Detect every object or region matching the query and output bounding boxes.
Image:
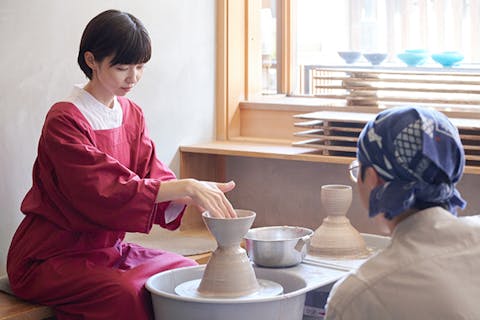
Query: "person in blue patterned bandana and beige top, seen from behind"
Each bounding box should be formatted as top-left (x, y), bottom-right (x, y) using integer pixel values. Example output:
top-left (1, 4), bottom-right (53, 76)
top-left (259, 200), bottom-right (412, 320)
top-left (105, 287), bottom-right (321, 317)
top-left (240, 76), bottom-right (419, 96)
top-left (325, 107), bottom-right (480, 320)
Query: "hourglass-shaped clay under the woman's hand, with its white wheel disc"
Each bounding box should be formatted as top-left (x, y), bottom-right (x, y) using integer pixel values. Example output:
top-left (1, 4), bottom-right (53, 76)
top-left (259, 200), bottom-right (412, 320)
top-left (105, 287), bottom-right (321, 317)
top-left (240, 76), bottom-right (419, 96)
top-left (175, 209), bottom-right (283, 298)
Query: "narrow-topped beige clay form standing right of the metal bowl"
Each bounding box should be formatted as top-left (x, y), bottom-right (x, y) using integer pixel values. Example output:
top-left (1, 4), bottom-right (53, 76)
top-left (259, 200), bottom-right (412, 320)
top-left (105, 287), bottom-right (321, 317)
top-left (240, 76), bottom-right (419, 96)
top-left (309, 184), bottom-right (369, 259)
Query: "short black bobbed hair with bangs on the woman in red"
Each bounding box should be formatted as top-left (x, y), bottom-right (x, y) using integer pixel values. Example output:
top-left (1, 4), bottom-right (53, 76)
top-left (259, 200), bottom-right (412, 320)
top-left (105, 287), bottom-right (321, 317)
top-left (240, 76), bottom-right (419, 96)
top-left (77, 10), bottom-right (152, 80)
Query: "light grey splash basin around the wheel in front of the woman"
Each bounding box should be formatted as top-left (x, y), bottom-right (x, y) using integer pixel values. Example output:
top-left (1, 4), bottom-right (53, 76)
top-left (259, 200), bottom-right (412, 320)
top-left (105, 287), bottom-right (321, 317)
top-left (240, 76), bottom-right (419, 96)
top-left (146, 266), bottom-right (328, 320)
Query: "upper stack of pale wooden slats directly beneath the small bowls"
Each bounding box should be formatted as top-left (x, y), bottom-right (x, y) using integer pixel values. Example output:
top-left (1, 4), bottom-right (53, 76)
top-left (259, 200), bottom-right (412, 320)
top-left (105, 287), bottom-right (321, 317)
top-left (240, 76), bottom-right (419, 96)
top-left (310, 66), bottom-right (480, 108)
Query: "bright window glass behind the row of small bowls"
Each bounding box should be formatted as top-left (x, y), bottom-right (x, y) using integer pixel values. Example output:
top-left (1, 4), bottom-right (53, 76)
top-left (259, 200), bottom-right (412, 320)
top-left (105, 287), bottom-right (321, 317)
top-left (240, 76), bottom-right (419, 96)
top-left (260, 0), bottom-right (480, 95)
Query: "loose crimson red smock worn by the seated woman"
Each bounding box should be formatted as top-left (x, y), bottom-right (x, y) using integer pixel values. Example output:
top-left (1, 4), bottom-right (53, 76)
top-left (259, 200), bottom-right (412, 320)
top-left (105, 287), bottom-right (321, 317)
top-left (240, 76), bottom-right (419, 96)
top-left (7, 97), bottom-right (196, 320)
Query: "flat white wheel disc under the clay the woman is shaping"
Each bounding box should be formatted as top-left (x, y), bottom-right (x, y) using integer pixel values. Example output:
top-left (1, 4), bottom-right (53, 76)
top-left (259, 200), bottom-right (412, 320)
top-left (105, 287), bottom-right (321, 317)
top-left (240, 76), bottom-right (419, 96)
top-left (175, 279), bottom-right (283, 300)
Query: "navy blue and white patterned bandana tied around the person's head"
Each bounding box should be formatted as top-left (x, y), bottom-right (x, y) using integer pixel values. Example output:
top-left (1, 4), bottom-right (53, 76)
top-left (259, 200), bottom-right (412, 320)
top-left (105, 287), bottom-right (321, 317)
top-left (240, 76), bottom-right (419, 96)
top-left (357, 107), bottom-right (466, 219)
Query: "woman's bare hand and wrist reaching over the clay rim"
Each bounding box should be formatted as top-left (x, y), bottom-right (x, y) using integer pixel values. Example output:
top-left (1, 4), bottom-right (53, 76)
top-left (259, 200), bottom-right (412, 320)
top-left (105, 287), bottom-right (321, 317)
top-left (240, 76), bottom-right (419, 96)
top-left (157, 179), bottom-right (237, 218)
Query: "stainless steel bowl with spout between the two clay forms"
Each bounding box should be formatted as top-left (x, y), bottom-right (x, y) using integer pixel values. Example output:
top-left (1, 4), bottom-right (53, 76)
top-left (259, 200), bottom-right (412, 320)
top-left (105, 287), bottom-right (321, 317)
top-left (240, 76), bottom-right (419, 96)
top-left (244, 226), bottom-right (313, 268)
